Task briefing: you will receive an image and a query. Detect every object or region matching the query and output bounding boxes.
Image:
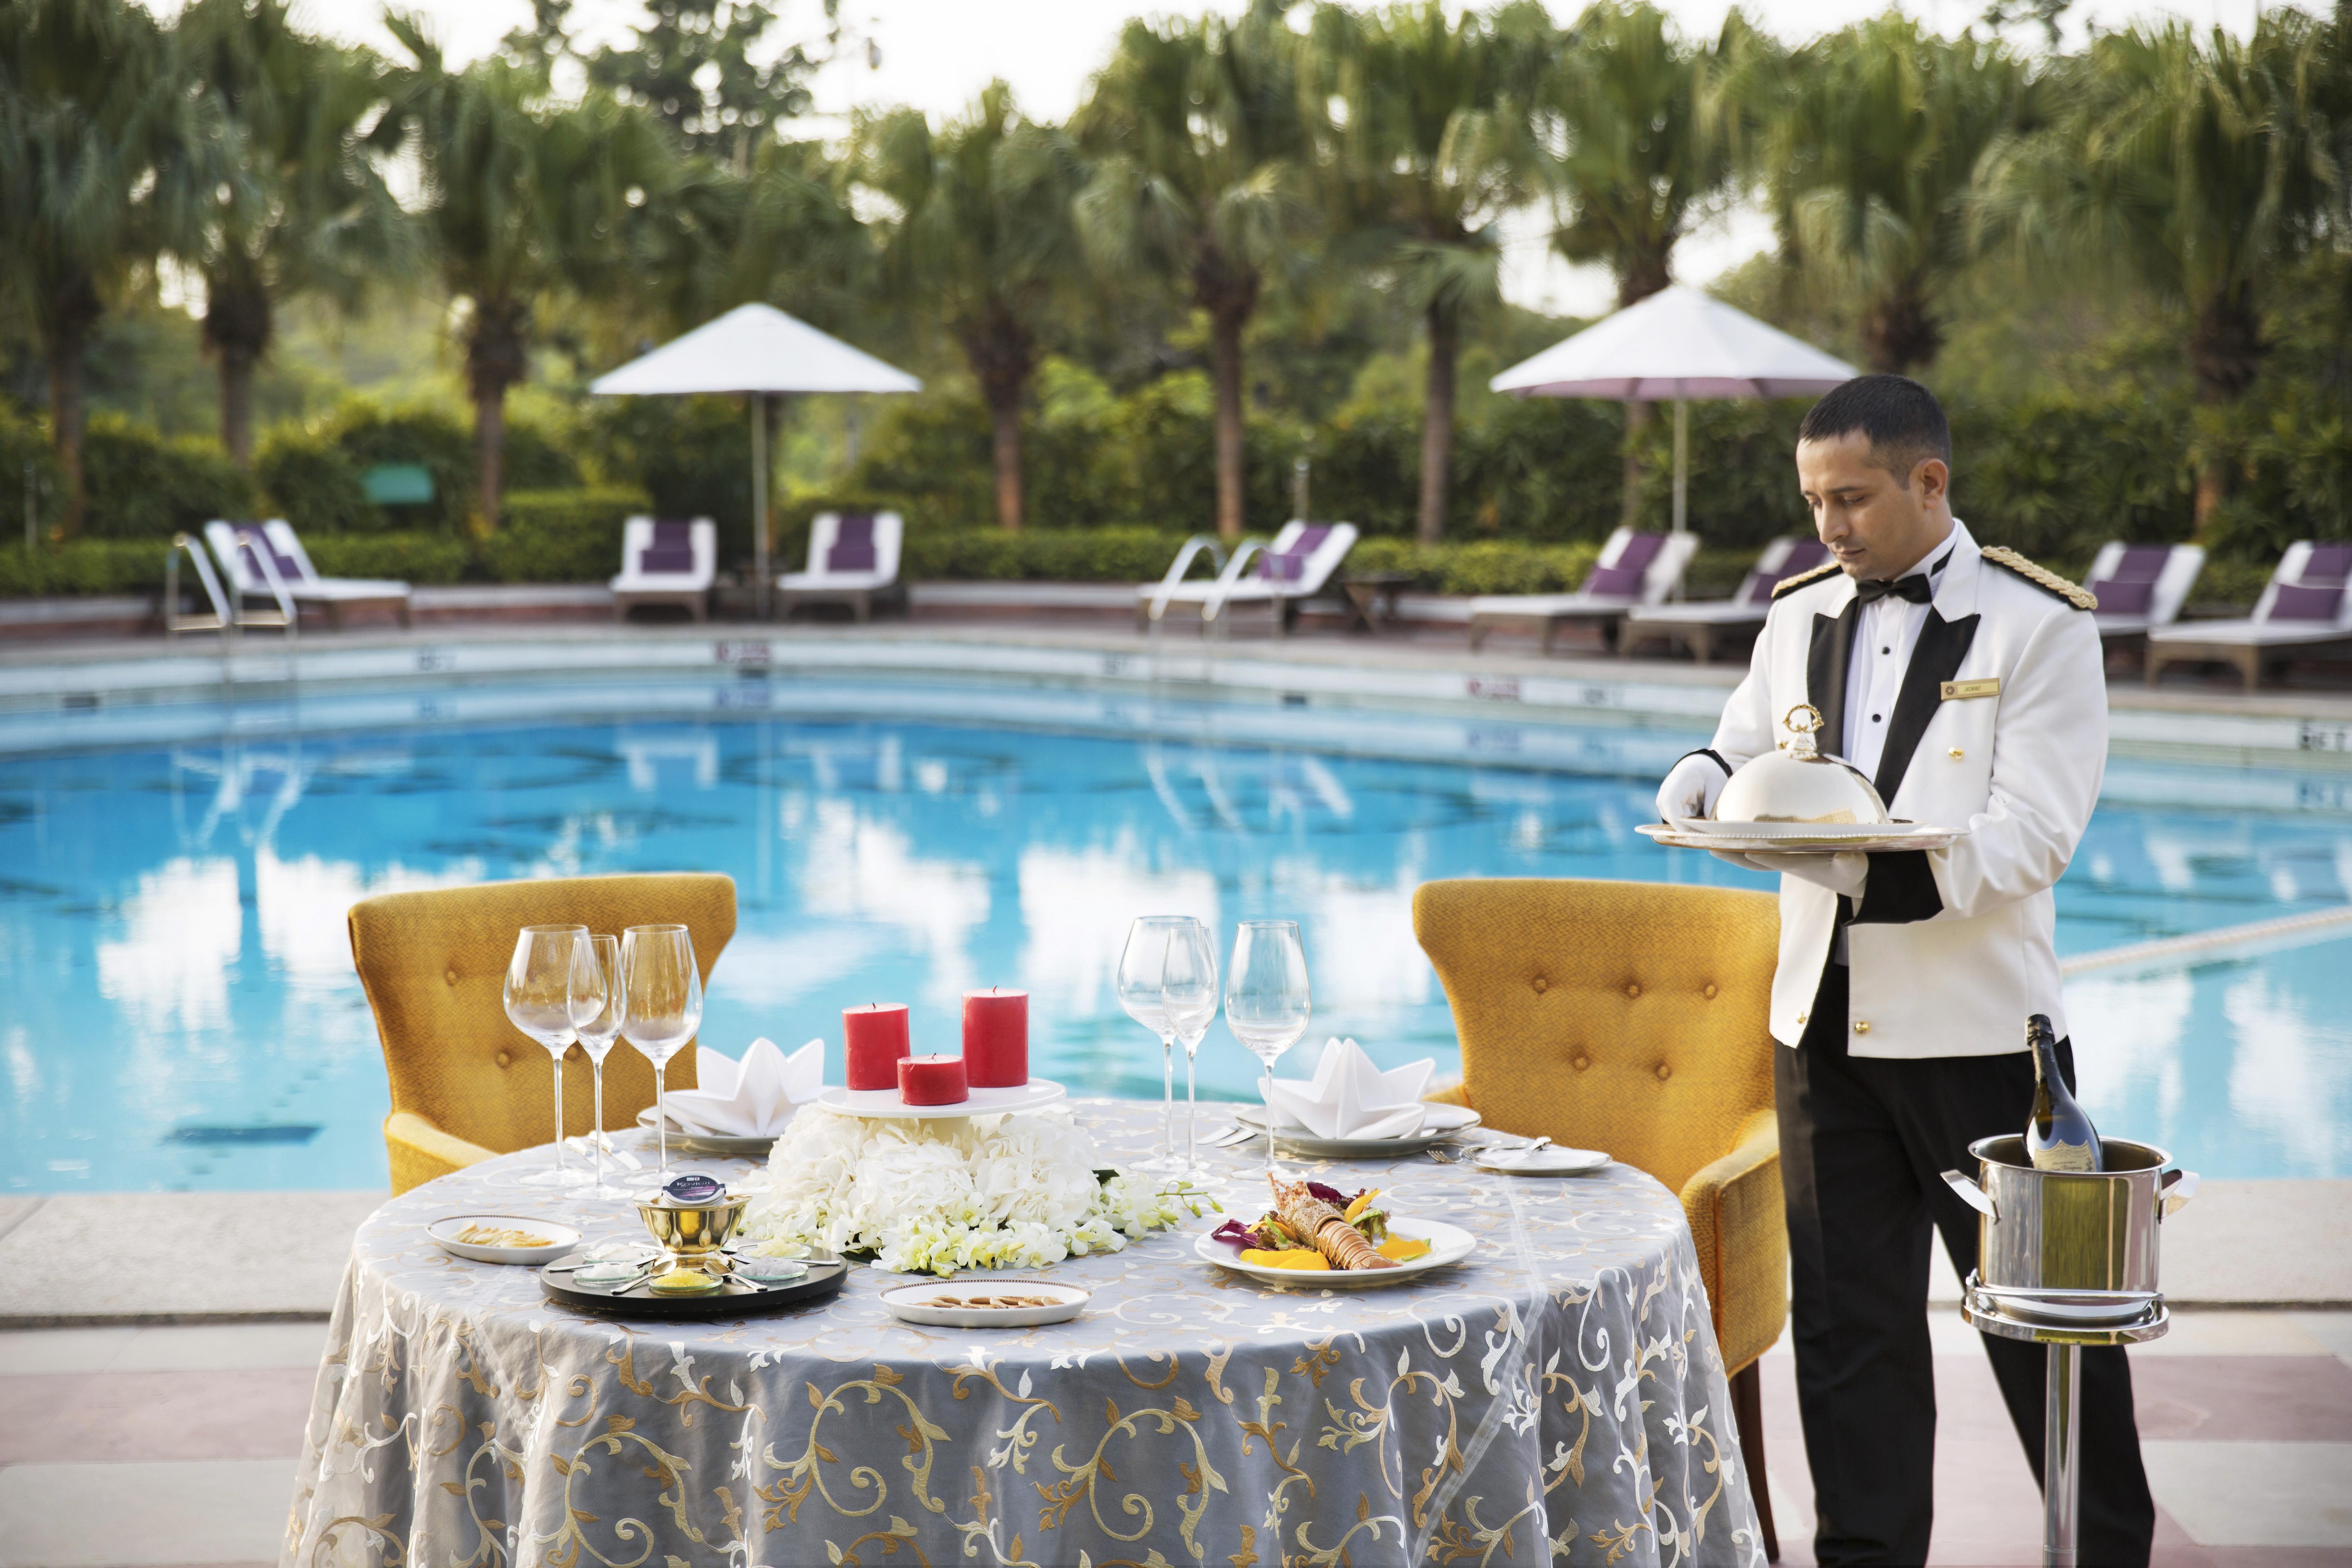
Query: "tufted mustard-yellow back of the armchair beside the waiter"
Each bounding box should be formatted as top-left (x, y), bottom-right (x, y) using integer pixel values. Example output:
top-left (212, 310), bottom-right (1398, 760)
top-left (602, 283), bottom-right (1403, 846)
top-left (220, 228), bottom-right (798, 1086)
top-left (1414, 877), bottom-right (1780, 1192)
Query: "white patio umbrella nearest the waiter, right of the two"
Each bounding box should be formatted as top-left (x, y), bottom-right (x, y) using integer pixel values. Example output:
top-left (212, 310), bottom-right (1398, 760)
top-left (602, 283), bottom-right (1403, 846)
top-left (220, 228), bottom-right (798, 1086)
top-left (1489, 282), bottom-right (1860, 534)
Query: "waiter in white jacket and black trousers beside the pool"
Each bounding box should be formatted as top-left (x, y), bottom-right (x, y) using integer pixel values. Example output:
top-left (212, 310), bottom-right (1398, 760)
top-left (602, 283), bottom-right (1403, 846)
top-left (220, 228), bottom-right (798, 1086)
top-left (1658, 376), bottom-right (2154, 1566)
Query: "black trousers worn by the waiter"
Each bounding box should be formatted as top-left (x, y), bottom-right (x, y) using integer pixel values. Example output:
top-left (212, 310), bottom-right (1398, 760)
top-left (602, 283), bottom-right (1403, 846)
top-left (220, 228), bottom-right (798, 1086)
top-left (1773, 964), bottom-right (2157, 1568)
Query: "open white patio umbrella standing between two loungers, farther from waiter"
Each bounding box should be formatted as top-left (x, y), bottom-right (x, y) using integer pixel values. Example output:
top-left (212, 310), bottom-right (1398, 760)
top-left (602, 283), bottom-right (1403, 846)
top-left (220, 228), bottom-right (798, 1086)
top-left (588, 305), bottom-right (922, 621)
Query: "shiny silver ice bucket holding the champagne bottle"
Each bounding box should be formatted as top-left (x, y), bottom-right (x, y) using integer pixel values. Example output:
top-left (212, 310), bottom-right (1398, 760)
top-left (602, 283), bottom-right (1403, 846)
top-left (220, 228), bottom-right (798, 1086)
top-left (1943, 1133), bottom-right (2197, 1326)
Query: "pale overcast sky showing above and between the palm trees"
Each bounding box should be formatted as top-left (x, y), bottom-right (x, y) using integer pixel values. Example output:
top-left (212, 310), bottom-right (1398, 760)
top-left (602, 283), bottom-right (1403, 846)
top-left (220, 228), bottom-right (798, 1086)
top-left (267, 0), bottom-right (2258, 315)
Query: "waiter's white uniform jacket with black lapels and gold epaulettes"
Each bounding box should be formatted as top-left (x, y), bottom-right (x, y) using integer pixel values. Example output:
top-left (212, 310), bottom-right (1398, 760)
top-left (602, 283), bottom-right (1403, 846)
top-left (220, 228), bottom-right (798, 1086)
top-left (1712, 522), bottom-right (2107, 1058)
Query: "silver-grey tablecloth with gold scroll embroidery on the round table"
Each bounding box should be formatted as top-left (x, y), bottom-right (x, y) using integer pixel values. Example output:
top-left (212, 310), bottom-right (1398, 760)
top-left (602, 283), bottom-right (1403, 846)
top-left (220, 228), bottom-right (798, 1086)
top-left (282, 1100), bottom-right (1764, 1568)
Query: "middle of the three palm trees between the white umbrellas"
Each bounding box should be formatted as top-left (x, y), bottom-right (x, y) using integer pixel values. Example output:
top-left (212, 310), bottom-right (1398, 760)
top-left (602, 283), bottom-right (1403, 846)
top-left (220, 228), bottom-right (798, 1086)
top-left (1070, 0), bottom-right (1312, 538)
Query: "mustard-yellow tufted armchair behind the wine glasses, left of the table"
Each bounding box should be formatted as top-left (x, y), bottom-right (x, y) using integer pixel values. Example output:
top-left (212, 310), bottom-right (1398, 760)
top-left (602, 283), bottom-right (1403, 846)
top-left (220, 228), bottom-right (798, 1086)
top-left (350, 872), bottom-right (734, 1192)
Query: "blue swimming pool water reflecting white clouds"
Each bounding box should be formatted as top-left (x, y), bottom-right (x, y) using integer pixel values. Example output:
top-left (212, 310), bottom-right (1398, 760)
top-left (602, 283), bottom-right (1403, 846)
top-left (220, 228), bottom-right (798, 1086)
top-left (0, 682), bottom-right (2352, 1192)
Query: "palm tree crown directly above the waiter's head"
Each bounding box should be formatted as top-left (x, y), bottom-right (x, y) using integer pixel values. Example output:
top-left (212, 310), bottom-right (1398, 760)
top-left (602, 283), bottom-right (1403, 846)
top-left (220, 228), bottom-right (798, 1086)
top-left (1762, 12), bottom-right (2030, 372)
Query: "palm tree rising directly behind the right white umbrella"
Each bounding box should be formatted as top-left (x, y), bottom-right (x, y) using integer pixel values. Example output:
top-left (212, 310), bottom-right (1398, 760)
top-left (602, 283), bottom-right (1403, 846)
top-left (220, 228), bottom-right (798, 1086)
top-left (1534, 0), bottom-right (1745, 524)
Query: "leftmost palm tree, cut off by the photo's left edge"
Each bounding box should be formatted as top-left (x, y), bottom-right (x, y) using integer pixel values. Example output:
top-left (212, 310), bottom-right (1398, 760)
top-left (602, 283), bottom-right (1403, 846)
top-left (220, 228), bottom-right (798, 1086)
top-left (0, 0), bottom-right (216, 534)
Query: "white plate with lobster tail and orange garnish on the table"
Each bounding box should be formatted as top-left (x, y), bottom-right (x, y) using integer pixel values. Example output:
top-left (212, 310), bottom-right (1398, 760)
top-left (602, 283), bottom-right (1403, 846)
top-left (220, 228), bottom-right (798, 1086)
top-left (1195, 1180), bottom-right (1475, 1288)
